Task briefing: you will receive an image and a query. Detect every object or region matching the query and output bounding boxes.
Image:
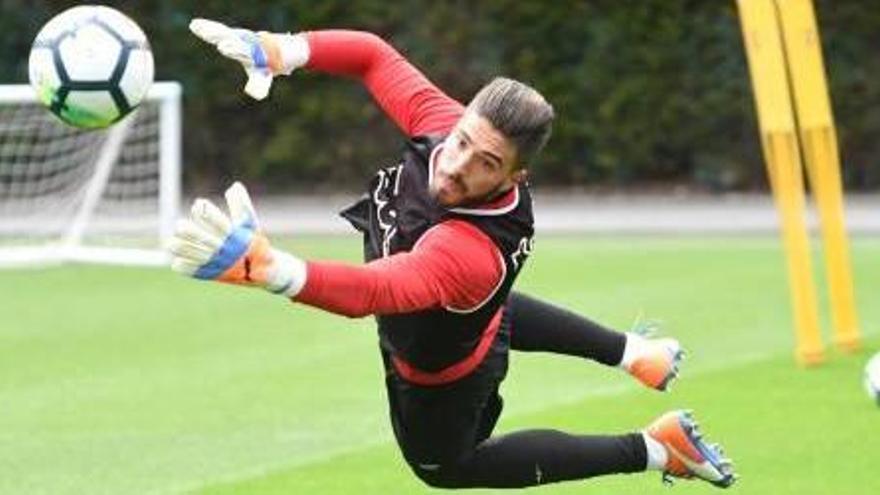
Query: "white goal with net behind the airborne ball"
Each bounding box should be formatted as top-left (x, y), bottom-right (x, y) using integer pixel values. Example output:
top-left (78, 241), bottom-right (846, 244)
top-left (0, 82), bottom-right (182, 267)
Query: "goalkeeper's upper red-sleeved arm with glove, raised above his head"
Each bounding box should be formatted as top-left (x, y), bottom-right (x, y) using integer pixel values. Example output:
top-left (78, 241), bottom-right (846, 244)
top-left (190, 19), bottom-right (464, 136)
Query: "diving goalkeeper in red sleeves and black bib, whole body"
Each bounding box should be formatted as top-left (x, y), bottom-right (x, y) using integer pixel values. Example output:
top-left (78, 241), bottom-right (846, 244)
top-left (170, 19), bottom-right (735, 488)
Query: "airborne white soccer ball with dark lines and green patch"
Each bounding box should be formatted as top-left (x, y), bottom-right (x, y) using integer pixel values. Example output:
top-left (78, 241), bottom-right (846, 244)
top-left (28, 5), bottom-right (153, 129)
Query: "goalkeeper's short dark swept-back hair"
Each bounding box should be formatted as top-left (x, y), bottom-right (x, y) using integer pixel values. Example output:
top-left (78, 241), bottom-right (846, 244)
top-left (468, 77), bottom-right (554, 164)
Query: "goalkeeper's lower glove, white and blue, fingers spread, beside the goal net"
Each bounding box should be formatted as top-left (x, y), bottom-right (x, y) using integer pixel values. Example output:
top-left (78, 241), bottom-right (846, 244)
top-left (169, 182), bottom-right (306, 297)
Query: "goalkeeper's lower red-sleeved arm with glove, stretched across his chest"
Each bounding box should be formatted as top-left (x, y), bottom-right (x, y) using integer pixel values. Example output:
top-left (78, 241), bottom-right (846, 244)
top-left (169, 183), bottom-right (504, 317)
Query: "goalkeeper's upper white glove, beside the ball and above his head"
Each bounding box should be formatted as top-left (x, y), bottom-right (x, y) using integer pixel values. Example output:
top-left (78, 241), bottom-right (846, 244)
top-left (189, 18), bottom-right (309, 100)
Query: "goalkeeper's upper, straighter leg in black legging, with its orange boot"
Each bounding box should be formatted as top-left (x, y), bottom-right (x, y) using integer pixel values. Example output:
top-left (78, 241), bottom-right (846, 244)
top-left (506, 292), bottom-right (684, 390)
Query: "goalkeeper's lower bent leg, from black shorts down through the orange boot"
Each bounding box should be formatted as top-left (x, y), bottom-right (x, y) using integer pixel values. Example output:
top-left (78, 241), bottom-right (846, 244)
top-left (387, 374), bottom-right (735, 488)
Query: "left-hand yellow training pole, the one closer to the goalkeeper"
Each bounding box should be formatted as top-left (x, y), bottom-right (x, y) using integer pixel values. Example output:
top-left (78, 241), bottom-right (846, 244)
top-left (737, 0), bottom-right (824, 365)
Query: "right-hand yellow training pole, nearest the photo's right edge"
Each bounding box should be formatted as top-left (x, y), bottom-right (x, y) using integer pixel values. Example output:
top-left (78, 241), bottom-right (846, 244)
top-left (776, 0), bottom-right (860, 351)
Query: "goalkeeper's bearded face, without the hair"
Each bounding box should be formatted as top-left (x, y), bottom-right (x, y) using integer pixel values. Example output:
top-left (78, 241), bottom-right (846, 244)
top-left (429, 111), bottom-right (526, 208)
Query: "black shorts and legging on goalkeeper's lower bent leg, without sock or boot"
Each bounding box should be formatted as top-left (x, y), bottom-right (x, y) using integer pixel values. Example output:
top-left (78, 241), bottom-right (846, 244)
top-left (384, 352), bottom-right (648, 488)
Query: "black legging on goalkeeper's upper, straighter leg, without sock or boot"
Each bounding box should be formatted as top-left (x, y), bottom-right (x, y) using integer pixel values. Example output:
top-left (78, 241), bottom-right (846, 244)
top-left (507, 292), bottom-right (626, 366)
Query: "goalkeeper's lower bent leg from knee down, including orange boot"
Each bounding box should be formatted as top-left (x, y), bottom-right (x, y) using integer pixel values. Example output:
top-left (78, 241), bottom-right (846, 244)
top-left (410, 411), bottom-right (736, 488)
